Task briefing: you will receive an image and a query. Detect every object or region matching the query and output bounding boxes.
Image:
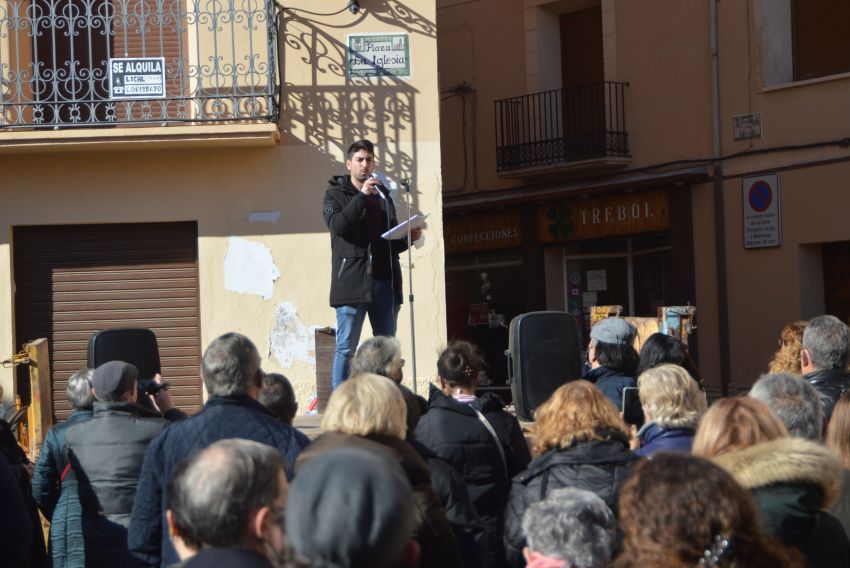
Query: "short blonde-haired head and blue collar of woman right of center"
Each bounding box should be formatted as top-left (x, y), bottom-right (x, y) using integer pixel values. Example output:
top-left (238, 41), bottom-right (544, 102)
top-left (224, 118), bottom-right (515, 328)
top-left (635, 364), bottom-right (706, 457)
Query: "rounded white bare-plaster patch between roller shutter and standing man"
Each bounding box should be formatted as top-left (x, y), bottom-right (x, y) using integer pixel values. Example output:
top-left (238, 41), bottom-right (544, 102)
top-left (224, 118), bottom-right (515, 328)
top-left (224, 237), bottom-right (280, 300)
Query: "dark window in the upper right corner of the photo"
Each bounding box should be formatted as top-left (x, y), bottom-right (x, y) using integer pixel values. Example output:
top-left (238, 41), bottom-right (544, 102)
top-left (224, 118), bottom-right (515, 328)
top-left (792, 0), bottom-right (850, 81)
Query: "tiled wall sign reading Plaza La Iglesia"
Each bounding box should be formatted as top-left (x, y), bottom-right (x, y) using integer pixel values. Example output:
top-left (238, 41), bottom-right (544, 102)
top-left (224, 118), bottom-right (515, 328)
top-left (348, 34), bottom-right (410, 77)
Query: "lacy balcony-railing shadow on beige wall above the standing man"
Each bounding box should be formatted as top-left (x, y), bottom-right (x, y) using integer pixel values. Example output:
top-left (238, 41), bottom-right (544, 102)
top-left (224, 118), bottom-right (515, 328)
top-left (278, 0), bottom-right (436, 216)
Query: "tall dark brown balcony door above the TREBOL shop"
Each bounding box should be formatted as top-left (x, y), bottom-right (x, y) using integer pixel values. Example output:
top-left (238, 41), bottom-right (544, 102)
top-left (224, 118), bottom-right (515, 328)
top-left (560, 6), bottom-right (605, 161)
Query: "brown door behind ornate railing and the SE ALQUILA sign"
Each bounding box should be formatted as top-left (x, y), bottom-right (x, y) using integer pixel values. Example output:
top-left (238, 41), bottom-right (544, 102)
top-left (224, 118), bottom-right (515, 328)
top-left (33, 0), bottom-right (187, 125)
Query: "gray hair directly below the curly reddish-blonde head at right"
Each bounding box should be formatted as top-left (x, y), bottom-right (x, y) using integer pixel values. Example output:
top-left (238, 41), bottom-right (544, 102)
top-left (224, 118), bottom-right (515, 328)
top-left (750, 373), bottom-right (823, 442)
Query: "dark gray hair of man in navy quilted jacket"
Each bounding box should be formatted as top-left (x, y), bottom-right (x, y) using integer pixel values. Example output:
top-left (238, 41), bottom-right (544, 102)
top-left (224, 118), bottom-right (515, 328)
top-left (203, 333), bottom-right (262, 396)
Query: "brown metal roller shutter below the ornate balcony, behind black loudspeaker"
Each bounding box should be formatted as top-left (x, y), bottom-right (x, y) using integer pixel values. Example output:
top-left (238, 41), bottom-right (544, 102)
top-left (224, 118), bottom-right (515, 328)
top-left (13, 222), bottom-right (201, 420)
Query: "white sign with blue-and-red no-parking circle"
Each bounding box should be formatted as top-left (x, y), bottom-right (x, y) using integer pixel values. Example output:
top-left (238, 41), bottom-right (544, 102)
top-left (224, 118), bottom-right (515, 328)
top-left (742, 174), bottom-right (782, 248)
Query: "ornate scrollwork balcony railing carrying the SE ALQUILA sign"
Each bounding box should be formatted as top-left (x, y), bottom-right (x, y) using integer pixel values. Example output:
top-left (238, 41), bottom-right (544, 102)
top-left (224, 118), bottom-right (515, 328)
top-left (0, 0), bottom-right (279, 129)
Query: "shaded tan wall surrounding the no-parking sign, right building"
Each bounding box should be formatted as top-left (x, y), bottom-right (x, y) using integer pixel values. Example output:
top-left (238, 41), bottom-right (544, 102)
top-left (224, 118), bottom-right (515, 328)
top-left (693, 0), bottom-right (850, 384)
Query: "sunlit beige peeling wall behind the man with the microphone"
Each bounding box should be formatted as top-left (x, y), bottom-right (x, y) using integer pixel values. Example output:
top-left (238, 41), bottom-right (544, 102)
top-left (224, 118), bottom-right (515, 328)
top-left (0, 0), bottom-right (446, 414)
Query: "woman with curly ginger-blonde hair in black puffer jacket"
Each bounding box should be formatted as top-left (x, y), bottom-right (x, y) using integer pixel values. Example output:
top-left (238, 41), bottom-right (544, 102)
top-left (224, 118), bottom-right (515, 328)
top-left (505, 380), bottom-right (639, 566)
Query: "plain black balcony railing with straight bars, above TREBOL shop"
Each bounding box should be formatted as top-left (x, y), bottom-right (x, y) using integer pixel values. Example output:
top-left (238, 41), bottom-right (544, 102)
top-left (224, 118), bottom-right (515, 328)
top-left (496, 81), bottom-right (629, 172)
